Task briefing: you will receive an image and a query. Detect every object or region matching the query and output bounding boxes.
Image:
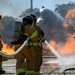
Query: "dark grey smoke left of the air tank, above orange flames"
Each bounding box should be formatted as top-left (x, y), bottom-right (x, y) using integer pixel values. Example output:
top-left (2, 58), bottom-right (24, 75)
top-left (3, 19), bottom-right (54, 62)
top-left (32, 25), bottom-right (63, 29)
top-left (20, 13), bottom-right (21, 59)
top-left (1, 16), bottom-right (15, 45)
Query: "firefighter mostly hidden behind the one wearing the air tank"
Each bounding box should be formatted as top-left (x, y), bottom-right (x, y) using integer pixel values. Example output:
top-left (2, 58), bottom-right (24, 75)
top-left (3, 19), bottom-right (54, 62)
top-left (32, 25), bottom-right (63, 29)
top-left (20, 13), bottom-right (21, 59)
top-left (31, 14), bottom-right (45, 75)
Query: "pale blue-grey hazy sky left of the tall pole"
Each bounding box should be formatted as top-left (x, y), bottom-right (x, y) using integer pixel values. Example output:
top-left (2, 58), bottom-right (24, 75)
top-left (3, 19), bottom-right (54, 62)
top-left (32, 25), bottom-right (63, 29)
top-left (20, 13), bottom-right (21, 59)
top-left (0, 0), bottom-right (30, 17)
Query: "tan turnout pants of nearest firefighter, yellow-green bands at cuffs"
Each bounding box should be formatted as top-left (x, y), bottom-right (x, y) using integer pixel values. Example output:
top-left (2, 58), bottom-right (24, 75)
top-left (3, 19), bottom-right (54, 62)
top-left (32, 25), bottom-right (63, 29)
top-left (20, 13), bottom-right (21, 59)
top-left (15, 46), bottom-right (34, 75)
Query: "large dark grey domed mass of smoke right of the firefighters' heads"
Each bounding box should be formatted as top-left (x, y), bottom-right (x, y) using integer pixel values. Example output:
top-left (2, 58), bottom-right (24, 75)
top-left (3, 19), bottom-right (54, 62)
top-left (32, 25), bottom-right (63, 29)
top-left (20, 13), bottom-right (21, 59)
top-left (34, 8), bottom-right (73, 43)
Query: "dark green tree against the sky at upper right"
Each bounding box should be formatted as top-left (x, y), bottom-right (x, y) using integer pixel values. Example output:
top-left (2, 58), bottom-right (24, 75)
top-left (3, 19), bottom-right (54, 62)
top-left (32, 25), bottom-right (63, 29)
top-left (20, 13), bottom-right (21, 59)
top-left (54, 2), bottom-right (75, 17)
